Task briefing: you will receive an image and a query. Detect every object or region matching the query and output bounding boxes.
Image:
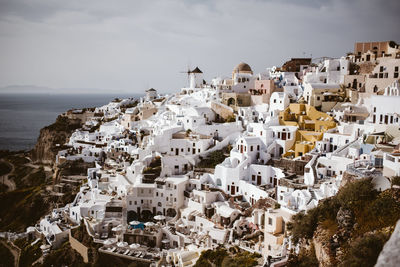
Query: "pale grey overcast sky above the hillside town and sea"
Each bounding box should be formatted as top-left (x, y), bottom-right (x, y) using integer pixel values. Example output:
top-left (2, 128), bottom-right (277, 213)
top-left (0, 0), bottom-right (400, 93)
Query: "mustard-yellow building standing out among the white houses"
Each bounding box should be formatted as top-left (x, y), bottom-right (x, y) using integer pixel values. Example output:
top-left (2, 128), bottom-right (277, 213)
top-left (279, 104), bottom-right (336, 157)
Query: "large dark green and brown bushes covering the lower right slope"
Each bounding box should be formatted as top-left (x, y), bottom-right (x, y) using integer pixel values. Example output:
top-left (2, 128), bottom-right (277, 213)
top-left (288, 179), bottom-right (400, 266)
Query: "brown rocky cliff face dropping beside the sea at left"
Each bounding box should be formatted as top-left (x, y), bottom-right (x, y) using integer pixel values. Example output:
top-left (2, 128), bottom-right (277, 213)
top-left (31, 116), bottom-right (81, 164)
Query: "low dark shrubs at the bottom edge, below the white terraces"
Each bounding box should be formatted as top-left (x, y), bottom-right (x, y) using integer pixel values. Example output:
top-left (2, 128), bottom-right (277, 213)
top-left (195, 247), bottom-right (261, 267)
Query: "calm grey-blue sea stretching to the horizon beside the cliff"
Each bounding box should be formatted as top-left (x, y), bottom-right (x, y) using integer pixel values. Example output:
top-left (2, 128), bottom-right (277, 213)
top-left (0, 94), bottom-right (143, 151)
